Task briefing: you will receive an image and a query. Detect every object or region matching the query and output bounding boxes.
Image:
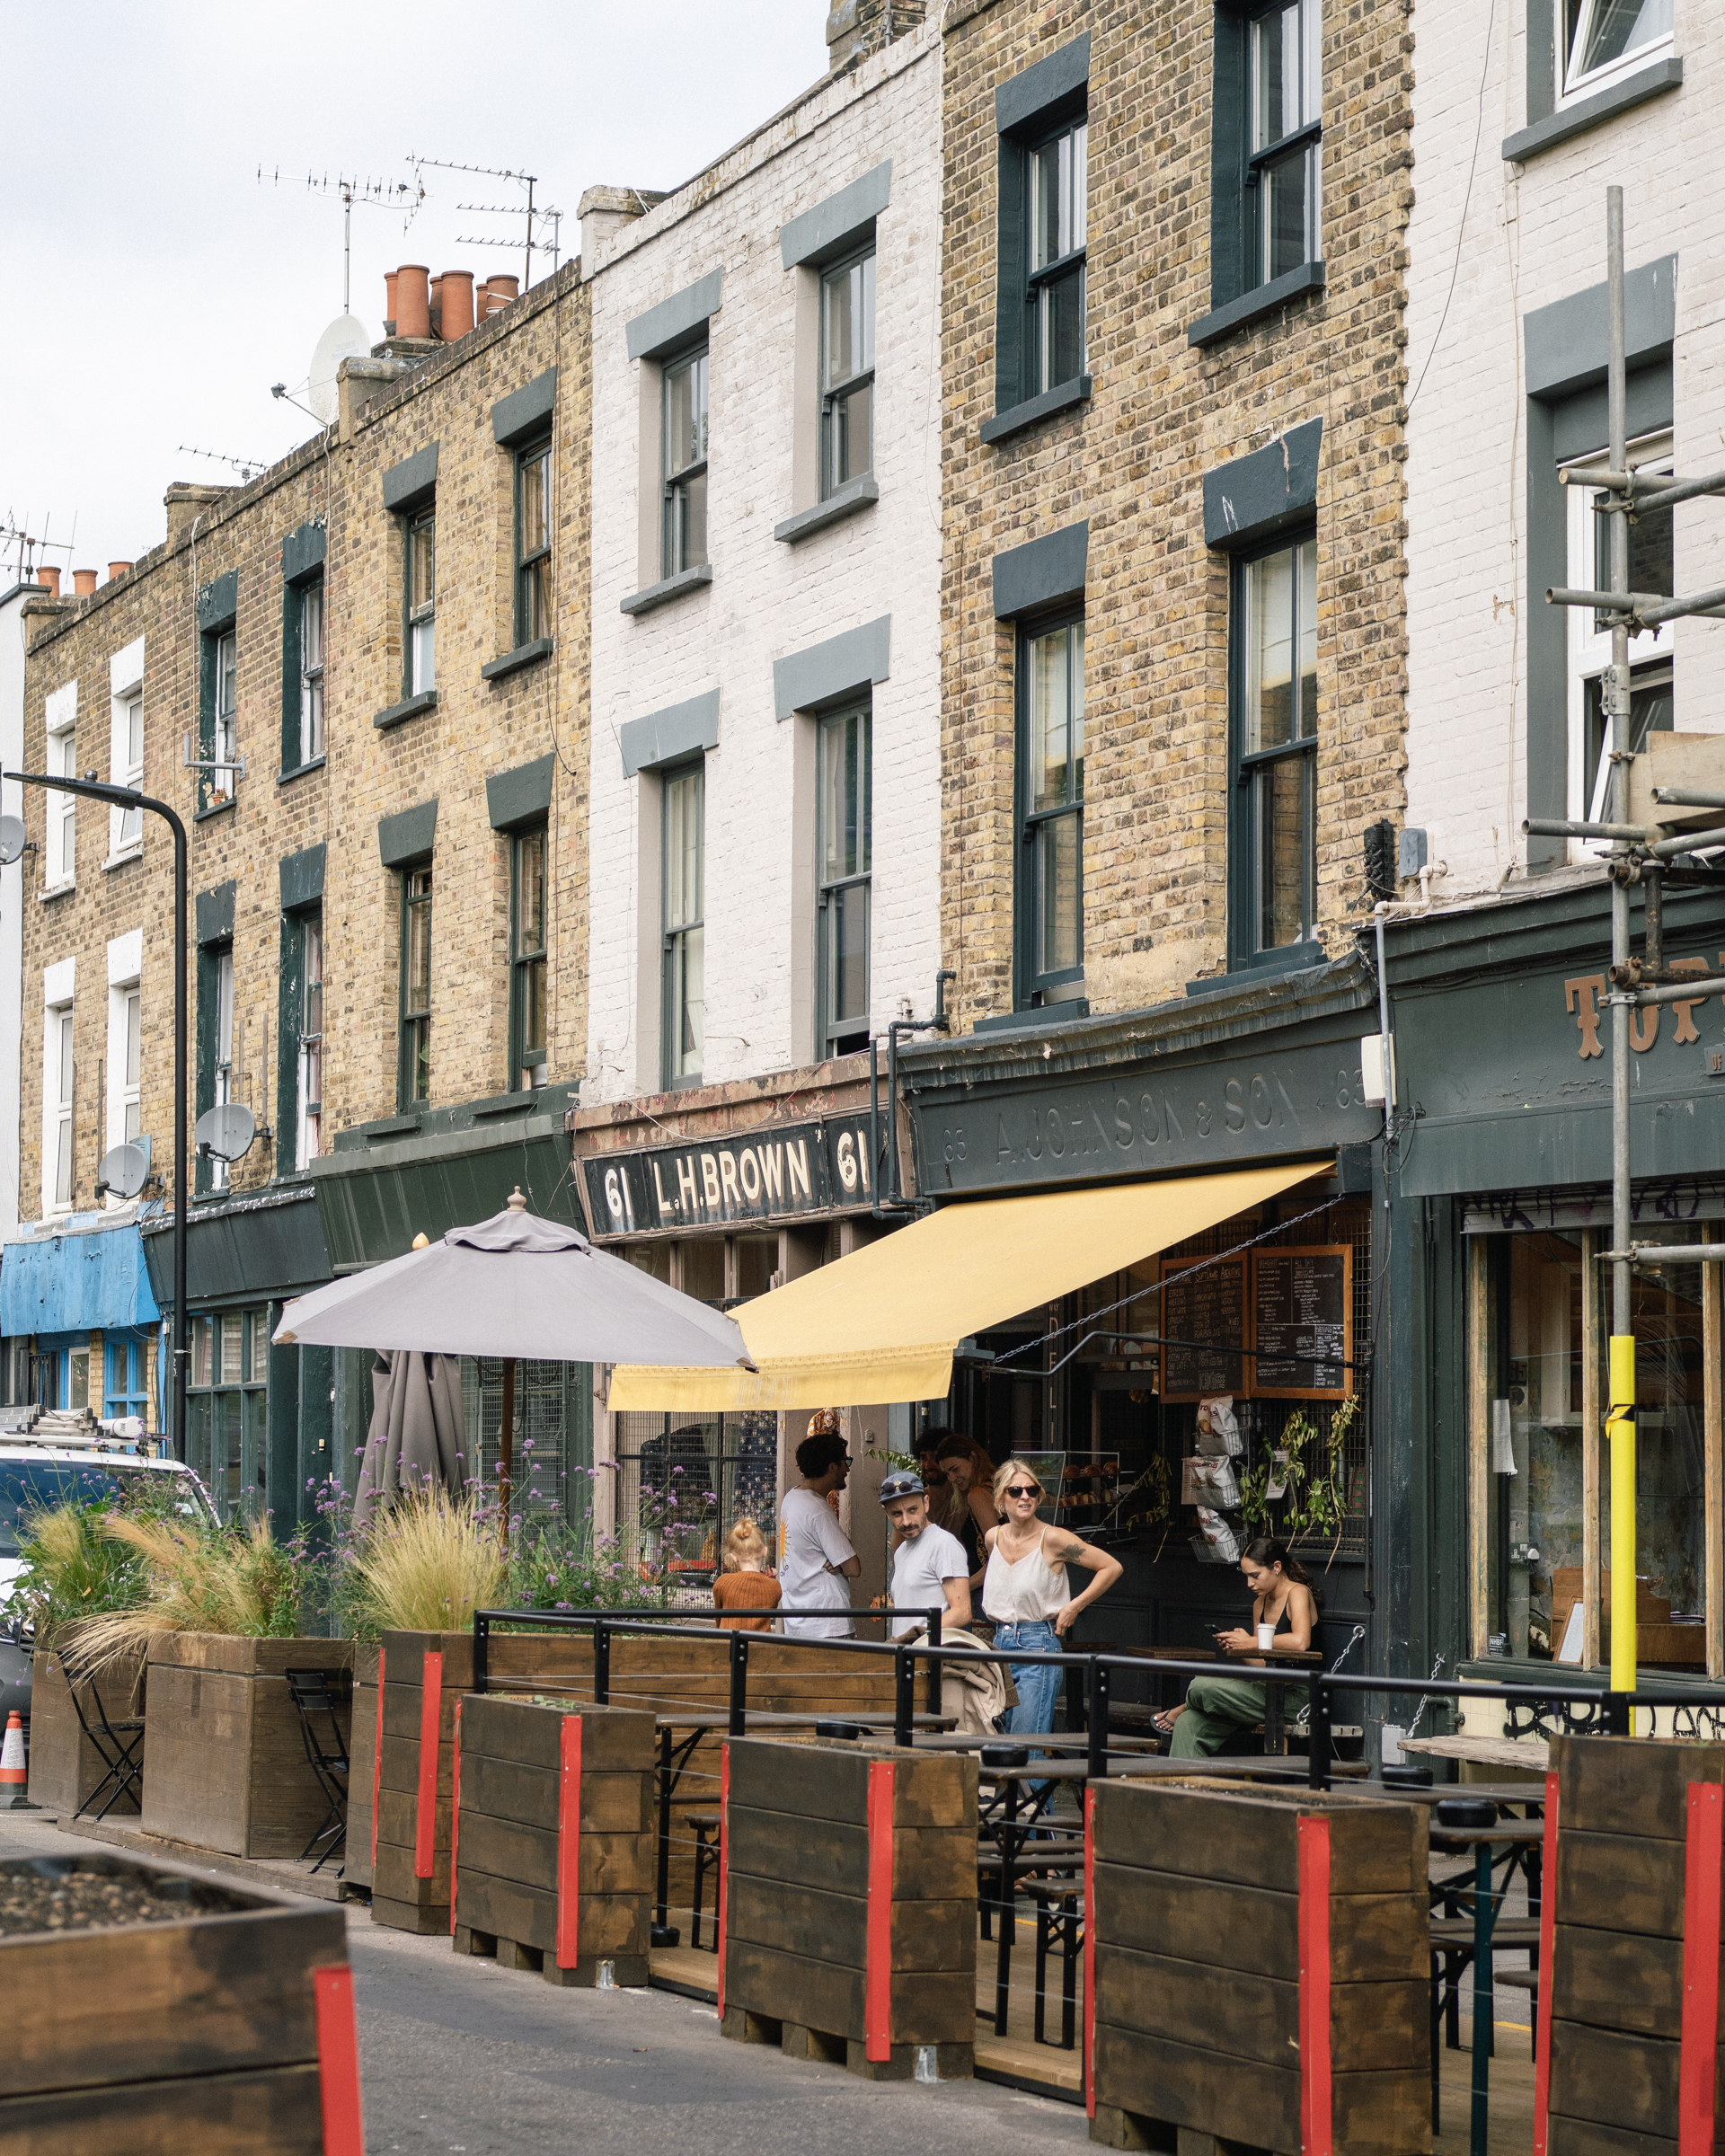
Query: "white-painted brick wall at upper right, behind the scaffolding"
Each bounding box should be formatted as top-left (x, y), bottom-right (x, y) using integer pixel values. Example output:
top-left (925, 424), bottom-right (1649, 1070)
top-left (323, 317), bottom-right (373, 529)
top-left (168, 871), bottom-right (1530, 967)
top-left (1406, 0), bottom-right (1725, 897)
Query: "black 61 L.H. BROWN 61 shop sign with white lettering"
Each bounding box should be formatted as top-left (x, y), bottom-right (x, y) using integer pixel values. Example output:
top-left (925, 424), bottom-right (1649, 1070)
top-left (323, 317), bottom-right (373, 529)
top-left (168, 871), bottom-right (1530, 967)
top-left (582, 1115), bottom-right (875, 1241)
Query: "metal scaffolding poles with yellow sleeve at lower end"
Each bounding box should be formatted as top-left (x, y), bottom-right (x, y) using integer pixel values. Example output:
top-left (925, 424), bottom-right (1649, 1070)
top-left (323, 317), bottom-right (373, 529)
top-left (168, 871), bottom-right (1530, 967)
top-left (1522, 188), bottom-right (1725, 1736)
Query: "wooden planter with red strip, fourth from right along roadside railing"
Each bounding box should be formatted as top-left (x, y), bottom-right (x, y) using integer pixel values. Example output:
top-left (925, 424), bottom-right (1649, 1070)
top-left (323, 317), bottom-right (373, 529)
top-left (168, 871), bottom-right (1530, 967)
top-left (455, 1694), bottom-right (653, 1985)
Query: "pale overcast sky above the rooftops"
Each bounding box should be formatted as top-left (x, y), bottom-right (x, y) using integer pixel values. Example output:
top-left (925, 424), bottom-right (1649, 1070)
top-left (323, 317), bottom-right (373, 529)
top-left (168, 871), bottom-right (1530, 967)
top-left (0, 0), bottom-right (826, 591)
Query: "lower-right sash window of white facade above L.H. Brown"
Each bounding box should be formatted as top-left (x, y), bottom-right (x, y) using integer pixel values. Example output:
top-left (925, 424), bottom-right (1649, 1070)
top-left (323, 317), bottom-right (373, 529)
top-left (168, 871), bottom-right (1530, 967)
top-left (815, 702), bottom-right (873, 1061)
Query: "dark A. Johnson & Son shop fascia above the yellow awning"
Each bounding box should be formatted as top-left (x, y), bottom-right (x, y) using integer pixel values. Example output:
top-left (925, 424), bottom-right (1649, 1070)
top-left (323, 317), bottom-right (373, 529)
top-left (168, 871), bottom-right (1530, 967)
top-left (912, 1037), bottom-right (1384, 1195)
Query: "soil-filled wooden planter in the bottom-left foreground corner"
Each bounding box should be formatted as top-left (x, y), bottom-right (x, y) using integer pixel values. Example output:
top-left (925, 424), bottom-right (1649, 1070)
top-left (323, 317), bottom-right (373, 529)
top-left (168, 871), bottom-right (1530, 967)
top-left (0, 1852), bottom-right (347, 2156)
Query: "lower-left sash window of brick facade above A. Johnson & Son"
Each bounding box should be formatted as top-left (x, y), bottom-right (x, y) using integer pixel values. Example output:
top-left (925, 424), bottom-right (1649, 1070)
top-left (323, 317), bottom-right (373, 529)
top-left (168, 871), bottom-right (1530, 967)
top-left (1015, 610), bottom-right (1084, 1009)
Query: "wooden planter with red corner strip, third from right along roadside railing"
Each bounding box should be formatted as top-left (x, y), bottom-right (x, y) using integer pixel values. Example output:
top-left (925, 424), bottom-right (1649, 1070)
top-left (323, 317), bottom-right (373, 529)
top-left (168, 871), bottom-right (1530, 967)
top-left (718, 1737), bottom-right (977, 2081)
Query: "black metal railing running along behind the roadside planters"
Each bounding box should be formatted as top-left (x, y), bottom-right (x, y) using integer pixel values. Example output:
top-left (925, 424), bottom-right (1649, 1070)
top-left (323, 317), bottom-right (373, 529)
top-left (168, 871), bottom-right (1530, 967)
top-left (473, 1608), bottom-right (1725, 1789)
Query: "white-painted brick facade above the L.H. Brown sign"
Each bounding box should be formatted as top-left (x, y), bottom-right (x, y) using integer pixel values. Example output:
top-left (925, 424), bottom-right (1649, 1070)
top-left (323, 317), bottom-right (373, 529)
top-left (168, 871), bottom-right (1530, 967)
top-left (584, 28), bottom-right (940, 1100)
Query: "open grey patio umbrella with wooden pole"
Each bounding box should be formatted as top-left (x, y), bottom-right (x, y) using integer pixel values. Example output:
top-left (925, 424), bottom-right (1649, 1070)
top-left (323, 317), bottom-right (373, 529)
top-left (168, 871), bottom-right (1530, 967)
top-left (276, 1190), bottom-right (755, 1522)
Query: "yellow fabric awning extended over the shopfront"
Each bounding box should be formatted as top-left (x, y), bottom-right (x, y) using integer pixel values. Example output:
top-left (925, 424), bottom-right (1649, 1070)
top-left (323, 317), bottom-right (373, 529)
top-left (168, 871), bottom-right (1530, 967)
top-left (610, 1162), bottom-right (1322, 1412)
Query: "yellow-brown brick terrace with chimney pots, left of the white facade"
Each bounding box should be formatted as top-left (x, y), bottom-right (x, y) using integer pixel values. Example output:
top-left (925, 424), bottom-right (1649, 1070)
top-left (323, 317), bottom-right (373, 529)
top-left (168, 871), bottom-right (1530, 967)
top-left (6, 263), bottom-right (588, 1531)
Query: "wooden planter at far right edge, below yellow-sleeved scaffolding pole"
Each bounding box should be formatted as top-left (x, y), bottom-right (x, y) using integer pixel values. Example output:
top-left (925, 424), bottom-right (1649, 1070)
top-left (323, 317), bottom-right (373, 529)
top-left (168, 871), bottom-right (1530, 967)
top-left (1535, 1736), bottom-right (1725, 2156)
